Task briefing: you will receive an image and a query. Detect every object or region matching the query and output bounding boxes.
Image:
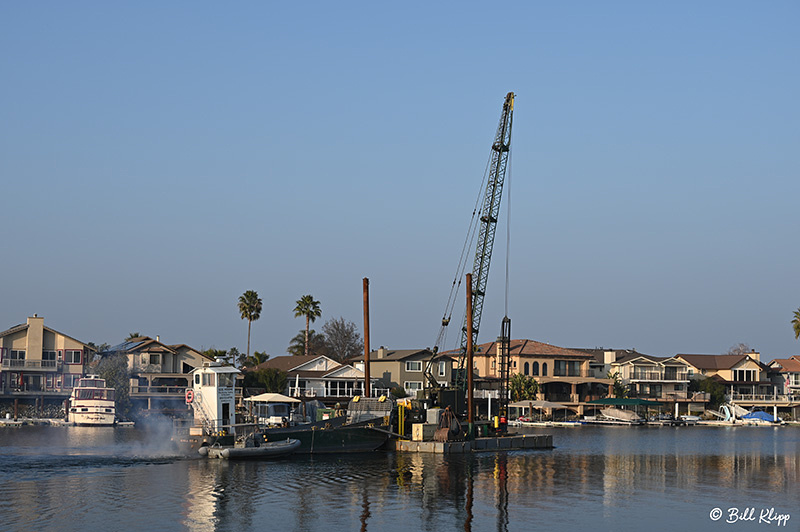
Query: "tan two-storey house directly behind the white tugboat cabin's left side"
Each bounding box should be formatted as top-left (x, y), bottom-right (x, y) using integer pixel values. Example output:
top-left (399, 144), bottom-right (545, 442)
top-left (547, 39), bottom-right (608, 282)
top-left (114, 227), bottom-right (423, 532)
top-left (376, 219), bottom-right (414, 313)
top-left (101, 336), bottom-right (214, 413)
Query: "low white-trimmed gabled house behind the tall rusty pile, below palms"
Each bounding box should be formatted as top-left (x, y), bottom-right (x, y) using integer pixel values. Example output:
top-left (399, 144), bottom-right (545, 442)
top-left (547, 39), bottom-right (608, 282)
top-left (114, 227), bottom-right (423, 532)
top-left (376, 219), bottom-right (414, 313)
top-left (250, 355), bottom-right (386, 404)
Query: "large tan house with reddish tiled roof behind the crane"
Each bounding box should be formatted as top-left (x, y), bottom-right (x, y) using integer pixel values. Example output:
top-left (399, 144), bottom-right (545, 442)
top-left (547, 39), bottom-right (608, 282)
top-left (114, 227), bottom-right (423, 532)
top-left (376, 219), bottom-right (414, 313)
top-left (473, 340), bottom-right (613, 414)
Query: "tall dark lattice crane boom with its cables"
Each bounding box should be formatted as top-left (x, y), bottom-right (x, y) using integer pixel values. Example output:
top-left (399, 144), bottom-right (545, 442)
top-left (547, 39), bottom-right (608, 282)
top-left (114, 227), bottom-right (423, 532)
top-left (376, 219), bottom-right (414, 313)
top-left (425, 92), bottom-right (514, 396)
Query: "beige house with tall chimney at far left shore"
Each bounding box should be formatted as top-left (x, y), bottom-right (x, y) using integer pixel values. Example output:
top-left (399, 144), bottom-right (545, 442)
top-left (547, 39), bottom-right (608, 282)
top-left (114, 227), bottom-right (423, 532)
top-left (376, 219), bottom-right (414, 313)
top-left (0, 314), bottom-right (94, 412)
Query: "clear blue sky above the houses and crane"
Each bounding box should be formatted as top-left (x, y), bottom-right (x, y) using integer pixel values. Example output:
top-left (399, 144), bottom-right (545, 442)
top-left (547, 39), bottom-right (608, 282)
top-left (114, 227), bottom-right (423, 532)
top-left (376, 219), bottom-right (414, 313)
top-left (0, 1), bottom-right (800, 359)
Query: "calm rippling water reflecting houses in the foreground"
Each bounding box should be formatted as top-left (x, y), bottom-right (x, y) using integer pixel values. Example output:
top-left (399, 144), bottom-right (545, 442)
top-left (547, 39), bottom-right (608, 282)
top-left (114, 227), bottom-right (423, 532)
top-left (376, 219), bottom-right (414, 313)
top-left (0, 427), bottom-right (800, 532)
